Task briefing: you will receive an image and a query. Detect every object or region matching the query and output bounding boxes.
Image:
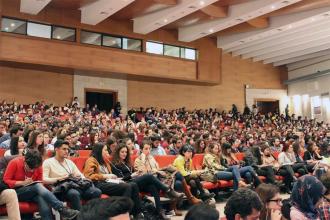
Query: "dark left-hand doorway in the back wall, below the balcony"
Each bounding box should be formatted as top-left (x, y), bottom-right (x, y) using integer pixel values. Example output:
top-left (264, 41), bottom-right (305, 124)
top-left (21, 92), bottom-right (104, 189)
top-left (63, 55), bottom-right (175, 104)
top-left (85, 89), bottom-right (118, 112)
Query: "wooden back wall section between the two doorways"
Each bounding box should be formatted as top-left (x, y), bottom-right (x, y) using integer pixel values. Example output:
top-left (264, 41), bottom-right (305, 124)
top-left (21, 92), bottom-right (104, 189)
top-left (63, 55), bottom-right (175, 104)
top-left (127, 54), bottom-right (287, 109)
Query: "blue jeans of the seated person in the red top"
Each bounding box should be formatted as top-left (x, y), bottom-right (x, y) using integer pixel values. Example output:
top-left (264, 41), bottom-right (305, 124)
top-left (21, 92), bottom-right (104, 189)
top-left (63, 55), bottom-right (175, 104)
top-left (16, 183), bottom-right (63, 220)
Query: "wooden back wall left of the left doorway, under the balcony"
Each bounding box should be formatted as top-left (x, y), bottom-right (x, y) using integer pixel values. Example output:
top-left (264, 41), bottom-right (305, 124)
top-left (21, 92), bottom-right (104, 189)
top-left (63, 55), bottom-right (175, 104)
top-left (0, 64), bottom-right (73, 105)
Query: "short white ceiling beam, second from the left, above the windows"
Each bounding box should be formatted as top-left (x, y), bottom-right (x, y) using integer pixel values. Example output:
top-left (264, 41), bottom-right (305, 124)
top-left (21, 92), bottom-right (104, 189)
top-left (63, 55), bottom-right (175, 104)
top-left (80, 0), bottom-right (135, 25)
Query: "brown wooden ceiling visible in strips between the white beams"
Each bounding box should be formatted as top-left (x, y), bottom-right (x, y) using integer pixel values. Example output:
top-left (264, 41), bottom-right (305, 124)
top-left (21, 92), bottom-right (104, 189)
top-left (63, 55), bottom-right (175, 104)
top-left (47, 0), bottom-right (330, 36)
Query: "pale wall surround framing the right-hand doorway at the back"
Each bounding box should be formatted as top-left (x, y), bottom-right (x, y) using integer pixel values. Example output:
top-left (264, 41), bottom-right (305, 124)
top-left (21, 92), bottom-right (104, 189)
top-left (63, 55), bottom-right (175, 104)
top-left (246, 89), bottom-right (288, 113)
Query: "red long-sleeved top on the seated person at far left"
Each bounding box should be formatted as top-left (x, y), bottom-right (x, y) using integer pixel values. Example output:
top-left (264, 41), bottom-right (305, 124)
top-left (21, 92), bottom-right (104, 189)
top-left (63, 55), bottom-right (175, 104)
top-left (3, 157), bottom-right (42, 188)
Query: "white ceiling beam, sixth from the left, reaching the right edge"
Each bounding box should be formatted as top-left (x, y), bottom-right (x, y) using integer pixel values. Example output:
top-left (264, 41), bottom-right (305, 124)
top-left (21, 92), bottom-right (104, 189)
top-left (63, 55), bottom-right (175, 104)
top-left (230, 20), bottom-right (330, 59)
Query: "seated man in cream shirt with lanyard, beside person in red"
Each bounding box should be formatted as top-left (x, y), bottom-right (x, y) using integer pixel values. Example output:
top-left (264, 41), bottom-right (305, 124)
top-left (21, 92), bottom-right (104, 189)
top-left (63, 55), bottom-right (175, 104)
top-left (42, 139), bottom-right (101, 210)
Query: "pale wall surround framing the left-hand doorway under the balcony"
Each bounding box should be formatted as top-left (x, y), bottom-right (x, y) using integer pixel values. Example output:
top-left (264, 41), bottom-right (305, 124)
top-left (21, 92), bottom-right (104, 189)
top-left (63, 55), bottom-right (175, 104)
top-left (73, 70), bottom-right (127, 113)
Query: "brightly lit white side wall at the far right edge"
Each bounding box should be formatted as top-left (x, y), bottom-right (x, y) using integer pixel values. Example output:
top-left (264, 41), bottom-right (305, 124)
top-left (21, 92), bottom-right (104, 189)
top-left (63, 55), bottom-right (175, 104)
top-left (288, 60), bottom-right (330, 122)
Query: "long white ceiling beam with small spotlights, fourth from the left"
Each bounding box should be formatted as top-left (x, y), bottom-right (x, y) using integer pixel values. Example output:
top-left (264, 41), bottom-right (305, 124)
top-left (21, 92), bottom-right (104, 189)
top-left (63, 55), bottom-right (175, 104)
top-left (179, 0), bottom-right (301, 42)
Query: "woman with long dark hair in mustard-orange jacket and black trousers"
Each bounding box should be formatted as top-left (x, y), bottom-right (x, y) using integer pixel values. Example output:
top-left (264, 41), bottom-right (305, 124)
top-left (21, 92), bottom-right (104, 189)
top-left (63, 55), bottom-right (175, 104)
top-left (83, 143), bottom-right (143, 220)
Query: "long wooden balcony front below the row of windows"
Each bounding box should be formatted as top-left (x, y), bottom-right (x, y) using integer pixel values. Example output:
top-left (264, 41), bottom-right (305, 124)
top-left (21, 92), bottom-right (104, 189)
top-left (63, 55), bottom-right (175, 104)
top-left (0, 33), bottom-right (197, 80)
